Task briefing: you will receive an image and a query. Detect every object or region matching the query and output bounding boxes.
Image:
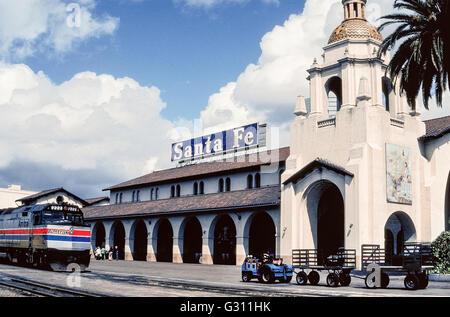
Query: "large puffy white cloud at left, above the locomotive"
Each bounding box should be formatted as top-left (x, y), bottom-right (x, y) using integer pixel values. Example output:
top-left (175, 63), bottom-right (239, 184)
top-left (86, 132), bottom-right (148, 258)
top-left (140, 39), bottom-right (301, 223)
top-left (0, 64), bottom-right (173, 194)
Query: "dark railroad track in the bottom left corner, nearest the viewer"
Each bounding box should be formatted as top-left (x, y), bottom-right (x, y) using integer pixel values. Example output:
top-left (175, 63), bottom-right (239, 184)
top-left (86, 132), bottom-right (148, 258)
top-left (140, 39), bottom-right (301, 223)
top-left (0, 278), bottom-right (103, 297)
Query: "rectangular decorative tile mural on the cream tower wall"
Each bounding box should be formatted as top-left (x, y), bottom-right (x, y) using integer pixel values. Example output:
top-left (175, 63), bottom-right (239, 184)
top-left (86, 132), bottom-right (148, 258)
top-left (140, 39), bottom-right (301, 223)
top-left (386, 143), bottom-right (412, 205)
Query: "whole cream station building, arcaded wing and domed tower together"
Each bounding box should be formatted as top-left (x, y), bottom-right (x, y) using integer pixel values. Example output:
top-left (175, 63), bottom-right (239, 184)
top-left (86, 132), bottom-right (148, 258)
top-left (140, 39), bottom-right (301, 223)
top-left (84, 0), bottom-right (450, 266)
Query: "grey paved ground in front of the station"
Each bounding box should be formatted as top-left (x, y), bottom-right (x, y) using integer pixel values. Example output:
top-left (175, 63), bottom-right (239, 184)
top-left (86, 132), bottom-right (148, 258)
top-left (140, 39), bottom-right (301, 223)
top-left (0, 260), bottom-right (450, 297)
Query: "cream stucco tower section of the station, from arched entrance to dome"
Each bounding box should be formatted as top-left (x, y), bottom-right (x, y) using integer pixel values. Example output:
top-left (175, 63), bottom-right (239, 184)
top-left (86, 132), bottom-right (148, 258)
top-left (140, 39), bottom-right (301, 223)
top-left (280, 0), bottom-right (450, 262)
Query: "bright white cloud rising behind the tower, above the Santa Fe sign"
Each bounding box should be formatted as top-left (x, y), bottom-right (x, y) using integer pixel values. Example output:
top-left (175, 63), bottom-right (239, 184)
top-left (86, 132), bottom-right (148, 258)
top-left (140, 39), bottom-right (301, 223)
top-left (201, 0), bottom-right (445, 141)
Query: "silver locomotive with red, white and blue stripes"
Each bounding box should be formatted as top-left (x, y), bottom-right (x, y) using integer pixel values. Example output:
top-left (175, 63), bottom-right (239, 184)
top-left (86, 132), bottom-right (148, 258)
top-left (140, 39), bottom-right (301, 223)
top-left (0, 204), bottom-right (91, 271)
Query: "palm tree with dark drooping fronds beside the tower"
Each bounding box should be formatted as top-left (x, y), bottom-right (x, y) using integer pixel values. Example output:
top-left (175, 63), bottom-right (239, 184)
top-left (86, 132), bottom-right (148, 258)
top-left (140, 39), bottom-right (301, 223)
top-left (378, 0), bottom-right (450, 111)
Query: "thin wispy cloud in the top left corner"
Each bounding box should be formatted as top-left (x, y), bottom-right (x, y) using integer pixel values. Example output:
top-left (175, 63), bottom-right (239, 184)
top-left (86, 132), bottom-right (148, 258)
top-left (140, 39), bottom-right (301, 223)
top-left (0, 0), bottom-right (119, 60)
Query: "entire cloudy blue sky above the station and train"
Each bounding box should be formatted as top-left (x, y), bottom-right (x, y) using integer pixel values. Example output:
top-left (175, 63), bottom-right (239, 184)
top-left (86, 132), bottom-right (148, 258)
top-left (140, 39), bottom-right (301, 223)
top-left (0, 0), bottom-right (449, 198)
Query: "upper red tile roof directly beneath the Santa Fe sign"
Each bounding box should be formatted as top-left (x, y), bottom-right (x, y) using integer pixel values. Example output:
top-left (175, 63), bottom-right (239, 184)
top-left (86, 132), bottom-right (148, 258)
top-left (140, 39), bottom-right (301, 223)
top-left (104, 147), bottom-right (289, 190)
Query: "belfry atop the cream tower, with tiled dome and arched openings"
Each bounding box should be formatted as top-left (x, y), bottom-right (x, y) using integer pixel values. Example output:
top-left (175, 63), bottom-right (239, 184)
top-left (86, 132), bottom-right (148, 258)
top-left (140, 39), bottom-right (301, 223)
top-left (308, 0), bottom-right (409, 119)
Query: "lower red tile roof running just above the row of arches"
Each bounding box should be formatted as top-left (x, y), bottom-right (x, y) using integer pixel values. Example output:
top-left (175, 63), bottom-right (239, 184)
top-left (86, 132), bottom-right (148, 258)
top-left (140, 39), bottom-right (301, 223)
top-left (83, 185), bottom-right (280, 220)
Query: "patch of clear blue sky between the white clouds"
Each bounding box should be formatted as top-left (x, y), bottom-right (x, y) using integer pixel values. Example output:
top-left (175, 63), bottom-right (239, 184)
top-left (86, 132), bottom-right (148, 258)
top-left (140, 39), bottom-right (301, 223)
top-left (22, 0), bottom-right (304, 120)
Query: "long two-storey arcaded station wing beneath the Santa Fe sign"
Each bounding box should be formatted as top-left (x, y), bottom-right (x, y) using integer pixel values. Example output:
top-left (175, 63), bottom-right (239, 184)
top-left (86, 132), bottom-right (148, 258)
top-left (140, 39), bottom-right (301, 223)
top-left (83, 148), bottom-right (289, 265)
